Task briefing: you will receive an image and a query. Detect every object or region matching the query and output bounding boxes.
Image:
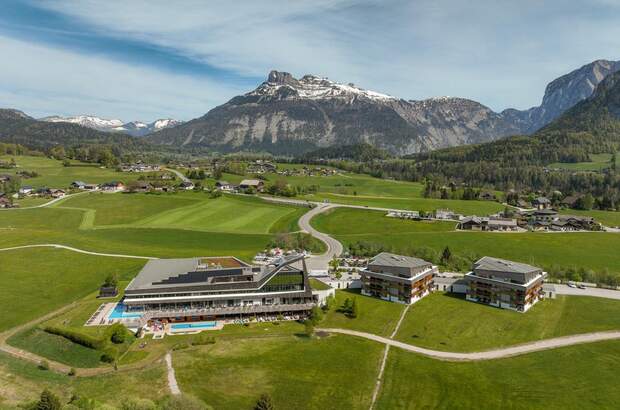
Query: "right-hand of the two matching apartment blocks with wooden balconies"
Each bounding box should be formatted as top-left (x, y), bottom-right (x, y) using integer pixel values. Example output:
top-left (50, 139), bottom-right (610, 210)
top-left (465, 256), bottom-right (547, 312)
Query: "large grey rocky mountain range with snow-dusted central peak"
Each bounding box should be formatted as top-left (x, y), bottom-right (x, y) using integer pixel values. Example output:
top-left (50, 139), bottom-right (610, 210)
top-left (149, 60), bottom-right (620, 155)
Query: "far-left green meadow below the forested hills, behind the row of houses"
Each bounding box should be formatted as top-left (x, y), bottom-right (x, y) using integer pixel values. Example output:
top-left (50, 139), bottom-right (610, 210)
top-left (0, 156), bottom-right (139, 188)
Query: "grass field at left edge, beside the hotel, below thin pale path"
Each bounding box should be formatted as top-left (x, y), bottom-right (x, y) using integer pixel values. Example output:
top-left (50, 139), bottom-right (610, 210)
top-left (0, 249), bottom-right (144, 331)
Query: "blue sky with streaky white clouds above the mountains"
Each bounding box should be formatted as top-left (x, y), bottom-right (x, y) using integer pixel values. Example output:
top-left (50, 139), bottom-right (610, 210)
top-left (0, 0), bottom-right (620, 121)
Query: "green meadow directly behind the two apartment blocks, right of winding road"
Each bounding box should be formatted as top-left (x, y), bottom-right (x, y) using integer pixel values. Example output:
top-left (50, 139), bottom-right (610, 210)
top-left (312, 208), bottom-right (620, 274)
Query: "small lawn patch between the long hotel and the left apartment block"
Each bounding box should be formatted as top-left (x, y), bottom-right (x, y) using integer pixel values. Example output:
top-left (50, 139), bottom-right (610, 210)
top-left (320, 290), bottom-right (404, 336)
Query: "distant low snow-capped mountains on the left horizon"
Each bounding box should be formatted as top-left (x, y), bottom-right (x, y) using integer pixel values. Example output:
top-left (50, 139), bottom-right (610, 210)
top-left (40, 115), bottom-right (183, 137)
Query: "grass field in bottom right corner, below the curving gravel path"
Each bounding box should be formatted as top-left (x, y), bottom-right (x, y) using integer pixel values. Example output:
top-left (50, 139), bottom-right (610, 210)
top-left (376, 341), bottom-right (620, 410)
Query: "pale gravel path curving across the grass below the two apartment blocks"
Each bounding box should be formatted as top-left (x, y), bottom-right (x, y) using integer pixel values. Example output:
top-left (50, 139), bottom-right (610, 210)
top-left (316, 328), bottom-right (620, 361)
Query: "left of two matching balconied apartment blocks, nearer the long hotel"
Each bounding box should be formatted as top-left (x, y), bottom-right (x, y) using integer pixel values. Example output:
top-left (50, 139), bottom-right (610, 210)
top-left (359, 252), bottom-right (438, 304)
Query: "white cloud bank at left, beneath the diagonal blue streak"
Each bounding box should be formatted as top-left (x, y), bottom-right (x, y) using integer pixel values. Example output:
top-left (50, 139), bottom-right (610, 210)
top-left (0, 37), bottom-right (241, 121)
